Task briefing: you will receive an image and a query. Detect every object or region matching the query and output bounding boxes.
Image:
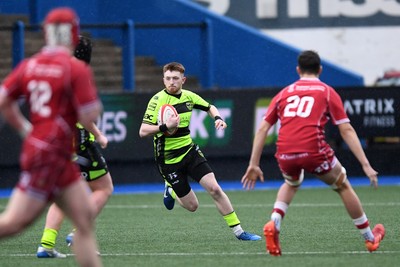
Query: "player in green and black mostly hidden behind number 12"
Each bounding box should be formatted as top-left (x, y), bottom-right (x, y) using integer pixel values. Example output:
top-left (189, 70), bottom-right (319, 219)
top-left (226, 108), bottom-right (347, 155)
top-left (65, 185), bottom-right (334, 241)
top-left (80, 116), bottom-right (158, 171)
top-left (36, 36), bottom-right (113, 258)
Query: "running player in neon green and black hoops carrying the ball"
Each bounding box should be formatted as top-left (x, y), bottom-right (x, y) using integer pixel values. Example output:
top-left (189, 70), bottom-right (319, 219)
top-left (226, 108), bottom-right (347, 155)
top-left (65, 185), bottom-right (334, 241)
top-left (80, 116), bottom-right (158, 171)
top-left (139, 62), bottom-right (261, 241)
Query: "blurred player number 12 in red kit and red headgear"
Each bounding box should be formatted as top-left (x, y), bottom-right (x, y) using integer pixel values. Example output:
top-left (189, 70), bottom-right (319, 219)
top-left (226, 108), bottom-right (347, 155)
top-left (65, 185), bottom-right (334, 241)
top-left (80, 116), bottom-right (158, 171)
top-left (0, 8), bottom-right (102, 266)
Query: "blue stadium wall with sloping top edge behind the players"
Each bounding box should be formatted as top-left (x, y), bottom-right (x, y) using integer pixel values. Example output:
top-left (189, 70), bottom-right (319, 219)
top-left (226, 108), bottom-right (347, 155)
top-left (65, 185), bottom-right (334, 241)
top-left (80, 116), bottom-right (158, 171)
top-left (0, 0), bottom-right (363, 89)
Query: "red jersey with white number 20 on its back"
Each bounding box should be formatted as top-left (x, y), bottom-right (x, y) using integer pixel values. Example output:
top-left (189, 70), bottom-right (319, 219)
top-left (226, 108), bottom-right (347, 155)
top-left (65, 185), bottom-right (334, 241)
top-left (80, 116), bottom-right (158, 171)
top-left (264, 78), bottom-right (350, 154)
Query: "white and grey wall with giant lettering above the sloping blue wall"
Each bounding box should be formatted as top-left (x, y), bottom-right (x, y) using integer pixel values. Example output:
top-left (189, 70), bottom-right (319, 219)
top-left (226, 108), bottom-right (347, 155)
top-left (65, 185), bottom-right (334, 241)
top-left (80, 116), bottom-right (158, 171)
top-left (208, 0), bottom-right (400, 86)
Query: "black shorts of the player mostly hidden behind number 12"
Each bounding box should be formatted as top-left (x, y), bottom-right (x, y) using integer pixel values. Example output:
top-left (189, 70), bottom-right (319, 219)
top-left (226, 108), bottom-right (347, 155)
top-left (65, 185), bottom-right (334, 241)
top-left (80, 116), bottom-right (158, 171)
top-left (75, 143), bottom-right (108, 182)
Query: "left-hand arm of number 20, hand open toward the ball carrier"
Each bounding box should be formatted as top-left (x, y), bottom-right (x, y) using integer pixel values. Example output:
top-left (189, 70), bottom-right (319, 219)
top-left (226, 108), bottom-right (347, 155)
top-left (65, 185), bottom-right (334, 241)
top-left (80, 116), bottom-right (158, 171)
top-left (241, 120), bottom-right (272, 190)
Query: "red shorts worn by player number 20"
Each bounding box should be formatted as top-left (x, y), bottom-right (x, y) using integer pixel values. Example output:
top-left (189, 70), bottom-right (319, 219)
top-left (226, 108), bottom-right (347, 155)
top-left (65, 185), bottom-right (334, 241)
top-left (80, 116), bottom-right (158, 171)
top-left (275, 147), bottom-right (337, 180)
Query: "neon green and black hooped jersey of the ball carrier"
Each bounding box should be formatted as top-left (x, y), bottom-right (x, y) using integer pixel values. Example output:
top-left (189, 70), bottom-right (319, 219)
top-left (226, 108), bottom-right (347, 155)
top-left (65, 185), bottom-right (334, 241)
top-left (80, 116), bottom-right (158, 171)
top-left (143, 89), bottom-right (210, 164)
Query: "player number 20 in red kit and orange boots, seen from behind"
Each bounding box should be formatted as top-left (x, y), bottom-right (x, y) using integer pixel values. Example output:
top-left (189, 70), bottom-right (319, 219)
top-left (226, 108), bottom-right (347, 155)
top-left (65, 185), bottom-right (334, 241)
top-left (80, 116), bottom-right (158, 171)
top-left (242, 51), bottom-right (385, 256)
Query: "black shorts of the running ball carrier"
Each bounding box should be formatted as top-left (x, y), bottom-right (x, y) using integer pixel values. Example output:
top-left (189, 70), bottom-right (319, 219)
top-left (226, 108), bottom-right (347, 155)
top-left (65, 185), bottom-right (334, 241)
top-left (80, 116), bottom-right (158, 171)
top-left (158, 145), bottom-right (212, 197)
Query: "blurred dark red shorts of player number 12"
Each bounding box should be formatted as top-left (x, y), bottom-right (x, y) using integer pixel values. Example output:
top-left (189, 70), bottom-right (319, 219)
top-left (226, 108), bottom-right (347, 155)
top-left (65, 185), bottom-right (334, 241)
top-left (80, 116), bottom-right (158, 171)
top-left (17, 142), bottom-right (80, 201)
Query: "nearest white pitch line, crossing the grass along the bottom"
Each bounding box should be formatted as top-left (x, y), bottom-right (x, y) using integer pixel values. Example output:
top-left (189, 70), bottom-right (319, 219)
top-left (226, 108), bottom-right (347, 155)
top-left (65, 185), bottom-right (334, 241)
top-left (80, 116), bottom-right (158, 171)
top-left (0, 251), bottom-right (400, 258)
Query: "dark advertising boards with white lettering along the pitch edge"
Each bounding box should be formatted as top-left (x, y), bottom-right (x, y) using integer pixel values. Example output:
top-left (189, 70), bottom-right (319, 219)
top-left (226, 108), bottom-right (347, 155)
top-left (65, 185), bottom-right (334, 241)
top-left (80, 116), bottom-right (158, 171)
top-left (0, 87), bottom-right (400, 187)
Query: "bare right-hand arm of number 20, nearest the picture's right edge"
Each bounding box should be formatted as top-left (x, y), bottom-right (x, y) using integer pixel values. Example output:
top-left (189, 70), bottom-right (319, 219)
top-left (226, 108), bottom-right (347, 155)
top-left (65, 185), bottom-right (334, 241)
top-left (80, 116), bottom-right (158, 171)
top-left (338, 123), bottom-right (378, 188)
